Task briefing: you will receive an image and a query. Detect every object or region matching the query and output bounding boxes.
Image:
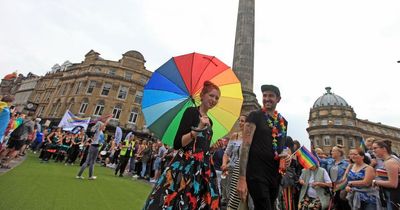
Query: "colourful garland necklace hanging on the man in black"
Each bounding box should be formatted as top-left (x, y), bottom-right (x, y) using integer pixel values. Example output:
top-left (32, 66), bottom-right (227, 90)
top-left (262, 108), bottom-right (286, 160)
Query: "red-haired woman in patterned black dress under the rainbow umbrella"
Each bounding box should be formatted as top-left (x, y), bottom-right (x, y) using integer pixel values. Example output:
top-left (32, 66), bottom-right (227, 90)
top-left (143, 81), bottom-right (221, 210)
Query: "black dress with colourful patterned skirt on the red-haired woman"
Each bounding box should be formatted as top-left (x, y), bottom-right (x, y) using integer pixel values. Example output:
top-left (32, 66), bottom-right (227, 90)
top-left (143, 107), bottom-right (220, 210)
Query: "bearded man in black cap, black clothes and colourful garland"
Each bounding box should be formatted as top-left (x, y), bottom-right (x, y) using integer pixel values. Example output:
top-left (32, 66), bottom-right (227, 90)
top-left (237, 85), bottom-right (290, 210)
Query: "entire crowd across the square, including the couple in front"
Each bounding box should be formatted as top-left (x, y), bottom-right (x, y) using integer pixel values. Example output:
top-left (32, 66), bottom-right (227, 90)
top-left (0, 81), bottom-right (400, 210)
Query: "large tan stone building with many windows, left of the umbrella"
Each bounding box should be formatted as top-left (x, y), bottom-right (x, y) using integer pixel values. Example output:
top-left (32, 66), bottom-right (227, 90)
top-left (31, 50), bottom-right (152, 131)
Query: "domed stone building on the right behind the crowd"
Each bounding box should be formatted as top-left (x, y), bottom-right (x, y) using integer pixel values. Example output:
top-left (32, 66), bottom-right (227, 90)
top-left (307, 87), bottom-right (400, 154)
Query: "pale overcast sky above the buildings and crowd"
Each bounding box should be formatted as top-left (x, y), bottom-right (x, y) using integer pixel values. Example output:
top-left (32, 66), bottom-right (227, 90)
top-left (0, 0), bottom-right (400, 148)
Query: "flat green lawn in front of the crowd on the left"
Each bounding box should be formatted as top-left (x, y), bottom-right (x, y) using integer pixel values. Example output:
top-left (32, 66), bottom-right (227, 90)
top-left (0, 154), bottom-right (151, 210)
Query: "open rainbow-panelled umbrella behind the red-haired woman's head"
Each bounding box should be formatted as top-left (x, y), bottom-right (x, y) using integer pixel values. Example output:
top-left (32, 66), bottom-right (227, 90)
top-left (142, 53), bottom-right (243, 145)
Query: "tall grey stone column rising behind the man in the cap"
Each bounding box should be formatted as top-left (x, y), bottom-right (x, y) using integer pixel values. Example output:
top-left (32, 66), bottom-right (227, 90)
top-left (232, 0), bottom-right (260, 114)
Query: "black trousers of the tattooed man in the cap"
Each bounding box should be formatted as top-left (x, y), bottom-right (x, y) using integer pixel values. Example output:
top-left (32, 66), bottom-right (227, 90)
top-left (247, 181), bottom-right (279, 210)
